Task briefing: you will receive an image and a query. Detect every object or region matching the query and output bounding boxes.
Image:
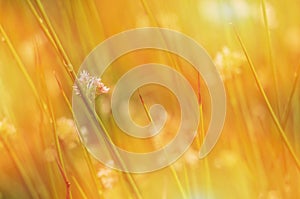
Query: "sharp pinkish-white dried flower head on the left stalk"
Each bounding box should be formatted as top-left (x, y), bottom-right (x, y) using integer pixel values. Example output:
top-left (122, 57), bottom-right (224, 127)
top-left (73, 70), bottom-right (109, 99)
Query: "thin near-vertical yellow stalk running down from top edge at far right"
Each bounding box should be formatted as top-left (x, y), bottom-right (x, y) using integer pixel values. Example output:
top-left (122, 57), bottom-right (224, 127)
top-left (261, 0), bottom-right (280, 118)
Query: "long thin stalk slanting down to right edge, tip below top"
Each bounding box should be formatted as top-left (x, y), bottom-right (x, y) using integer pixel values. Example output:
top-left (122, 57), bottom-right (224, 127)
top-left (233, 26), bottom-right (300, 170)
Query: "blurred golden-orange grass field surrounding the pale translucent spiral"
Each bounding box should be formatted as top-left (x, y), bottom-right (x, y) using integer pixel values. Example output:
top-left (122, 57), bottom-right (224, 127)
top-left (0, 0), bottom-right (300, 199)
